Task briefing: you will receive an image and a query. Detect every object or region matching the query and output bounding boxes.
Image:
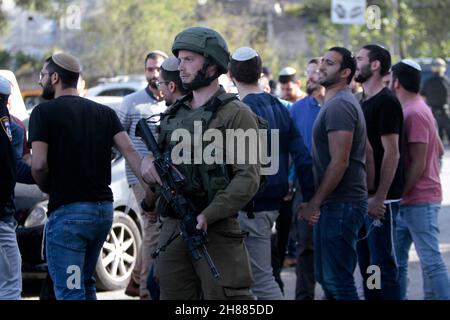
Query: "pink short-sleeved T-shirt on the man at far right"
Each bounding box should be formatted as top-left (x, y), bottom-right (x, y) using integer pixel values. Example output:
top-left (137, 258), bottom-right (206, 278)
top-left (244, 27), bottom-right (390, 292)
top-left (401, 97), bottom-right (442, 205)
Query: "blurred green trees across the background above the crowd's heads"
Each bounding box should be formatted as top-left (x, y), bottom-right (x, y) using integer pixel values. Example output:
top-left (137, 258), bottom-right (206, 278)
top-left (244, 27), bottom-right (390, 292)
top-left (0, 0), bottom-right (450, 77)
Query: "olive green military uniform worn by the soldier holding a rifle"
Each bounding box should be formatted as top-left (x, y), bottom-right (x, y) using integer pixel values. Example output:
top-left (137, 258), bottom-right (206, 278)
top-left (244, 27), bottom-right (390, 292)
top-left (156, 88), bottom-right (260, 299)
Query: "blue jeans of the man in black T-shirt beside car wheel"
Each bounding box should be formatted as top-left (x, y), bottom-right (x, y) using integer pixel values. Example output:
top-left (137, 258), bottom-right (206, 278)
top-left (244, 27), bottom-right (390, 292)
top-left (45, 201), bottom-right (113, 300)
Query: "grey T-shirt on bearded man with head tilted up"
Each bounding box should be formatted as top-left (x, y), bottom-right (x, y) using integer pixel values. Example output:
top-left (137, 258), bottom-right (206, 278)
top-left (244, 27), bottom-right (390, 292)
top-left (312, 89), bottom-right (367, 202)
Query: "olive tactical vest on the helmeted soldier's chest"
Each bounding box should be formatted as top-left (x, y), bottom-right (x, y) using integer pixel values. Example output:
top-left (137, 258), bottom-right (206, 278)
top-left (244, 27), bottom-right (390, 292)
top-left (158, 93), bottom-right (267, 216)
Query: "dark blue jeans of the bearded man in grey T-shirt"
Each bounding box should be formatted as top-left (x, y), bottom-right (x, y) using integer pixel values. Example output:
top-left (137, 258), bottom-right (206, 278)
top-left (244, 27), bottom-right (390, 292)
top-left (314, 200), bottom-right (367, 300)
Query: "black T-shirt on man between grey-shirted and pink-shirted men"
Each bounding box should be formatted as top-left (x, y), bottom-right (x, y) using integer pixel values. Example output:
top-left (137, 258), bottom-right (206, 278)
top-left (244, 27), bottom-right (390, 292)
top-left (361, 88), bottom-right (405, 200)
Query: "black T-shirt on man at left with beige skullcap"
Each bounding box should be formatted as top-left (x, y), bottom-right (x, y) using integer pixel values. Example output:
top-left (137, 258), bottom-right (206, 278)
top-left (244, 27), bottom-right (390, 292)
top-left (29, 96), bottom-right (123, 212)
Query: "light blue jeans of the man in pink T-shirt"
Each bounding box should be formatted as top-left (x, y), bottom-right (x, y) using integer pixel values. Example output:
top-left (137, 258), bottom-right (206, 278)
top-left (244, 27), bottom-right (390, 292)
top-left (395, 203), bottom-right (450, 300)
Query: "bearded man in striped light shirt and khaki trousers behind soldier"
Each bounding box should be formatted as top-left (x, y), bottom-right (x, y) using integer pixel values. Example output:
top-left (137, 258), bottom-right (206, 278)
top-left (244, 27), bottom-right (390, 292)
top-left (117, 50), bottom-right (167, 299)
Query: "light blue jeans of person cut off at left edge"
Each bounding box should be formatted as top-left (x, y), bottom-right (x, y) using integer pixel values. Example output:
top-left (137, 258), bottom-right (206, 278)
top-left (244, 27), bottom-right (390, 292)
top-left (0, 220), bottom-right (22, 300)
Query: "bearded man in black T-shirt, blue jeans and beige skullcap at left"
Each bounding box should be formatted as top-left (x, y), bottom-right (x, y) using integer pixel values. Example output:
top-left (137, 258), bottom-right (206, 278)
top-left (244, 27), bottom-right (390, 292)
top-left (29, 52), bottom-right (147, 300)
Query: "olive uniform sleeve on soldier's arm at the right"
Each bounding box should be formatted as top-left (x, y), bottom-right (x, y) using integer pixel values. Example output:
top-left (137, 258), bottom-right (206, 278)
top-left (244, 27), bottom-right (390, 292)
top-left (202, 109), bottom-right (260, 225)
